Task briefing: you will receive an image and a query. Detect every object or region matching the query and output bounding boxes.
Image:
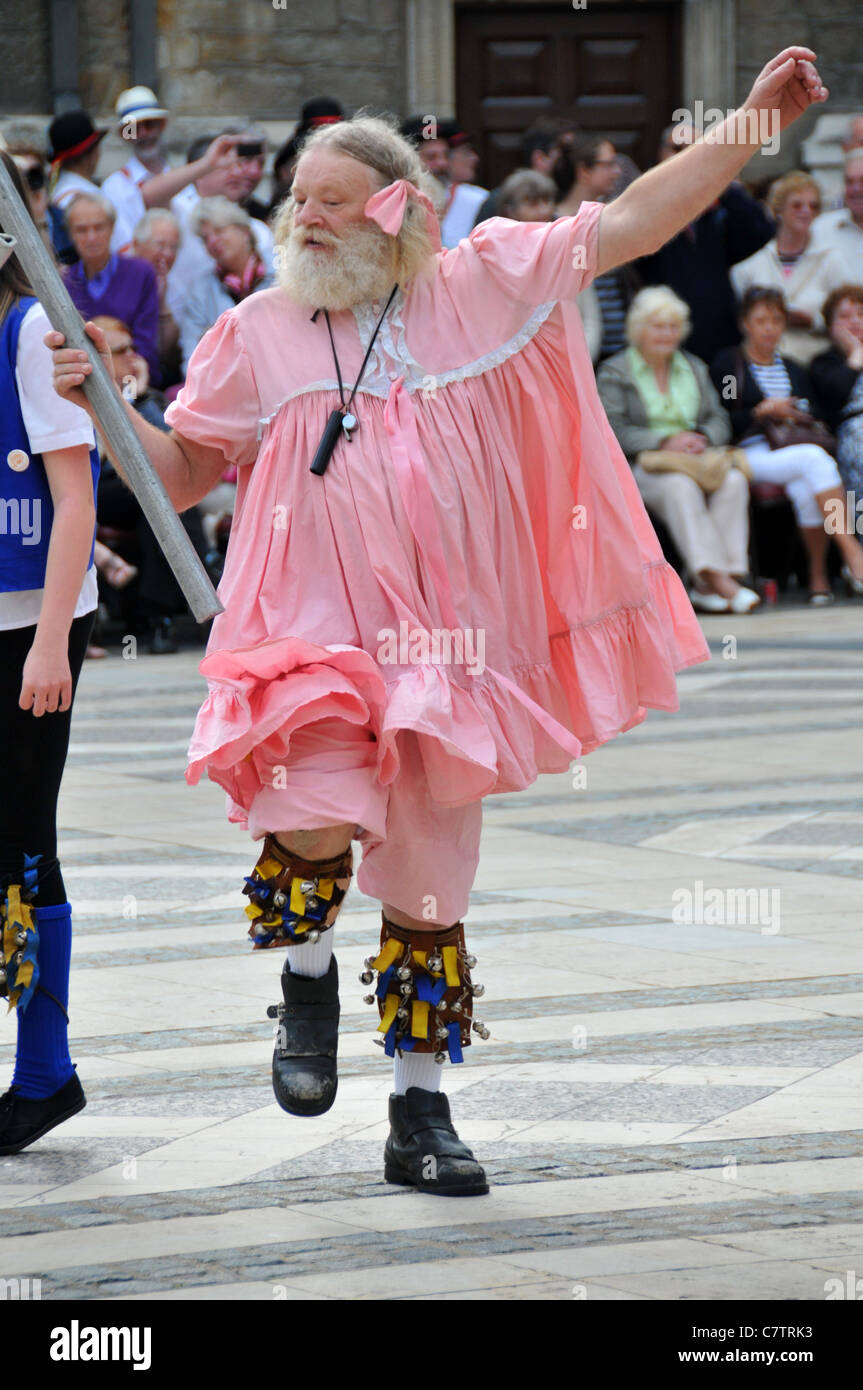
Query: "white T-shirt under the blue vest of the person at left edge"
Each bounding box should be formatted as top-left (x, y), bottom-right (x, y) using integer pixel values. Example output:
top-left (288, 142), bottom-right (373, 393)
top-left (0, 304), bottom-right (99, 630)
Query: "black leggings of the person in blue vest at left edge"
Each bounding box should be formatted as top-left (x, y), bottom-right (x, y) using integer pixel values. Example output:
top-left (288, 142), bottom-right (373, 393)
top-left (0, 612), bottom-right (96, 908)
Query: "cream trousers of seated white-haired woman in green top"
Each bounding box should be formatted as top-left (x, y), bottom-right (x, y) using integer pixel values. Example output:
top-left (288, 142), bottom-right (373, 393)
top-left (632, 463), bottom-right (749, 578)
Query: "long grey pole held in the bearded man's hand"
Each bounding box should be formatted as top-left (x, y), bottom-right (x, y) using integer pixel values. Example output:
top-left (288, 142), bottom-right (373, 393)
top-left (0, 160), bottom-right (222, 623)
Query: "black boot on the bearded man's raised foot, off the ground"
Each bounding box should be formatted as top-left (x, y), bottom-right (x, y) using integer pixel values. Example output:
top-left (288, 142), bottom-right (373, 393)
top-left (267, 956), bottom-right (339, 1115)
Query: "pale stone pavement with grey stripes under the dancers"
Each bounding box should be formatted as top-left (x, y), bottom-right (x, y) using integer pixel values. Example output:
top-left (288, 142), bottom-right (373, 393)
top-left (0, 602), bottom-right (863, 1301)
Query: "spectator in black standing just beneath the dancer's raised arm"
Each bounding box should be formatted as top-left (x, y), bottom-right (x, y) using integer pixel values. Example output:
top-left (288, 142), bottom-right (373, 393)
top-left (636, 124), bottom-right (774, 363)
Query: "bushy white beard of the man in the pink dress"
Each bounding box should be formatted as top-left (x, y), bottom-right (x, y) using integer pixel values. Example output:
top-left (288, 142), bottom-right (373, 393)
top-left (277, 222), bottom-right (395, 310)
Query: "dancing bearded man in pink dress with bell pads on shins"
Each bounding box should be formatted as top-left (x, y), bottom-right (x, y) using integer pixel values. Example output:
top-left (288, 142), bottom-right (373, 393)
top-left (49, 49), bottom-right (827, 1195)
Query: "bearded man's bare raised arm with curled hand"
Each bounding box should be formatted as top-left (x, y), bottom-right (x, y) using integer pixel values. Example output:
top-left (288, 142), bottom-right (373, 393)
top-left (596, 47), bottom-right (828, 275)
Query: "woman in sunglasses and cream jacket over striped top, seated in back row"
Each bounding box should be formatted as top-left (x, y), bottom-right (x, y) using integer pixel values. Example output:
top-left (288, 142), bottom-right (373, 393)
top-left (731, 170), bottom-right (845, 366)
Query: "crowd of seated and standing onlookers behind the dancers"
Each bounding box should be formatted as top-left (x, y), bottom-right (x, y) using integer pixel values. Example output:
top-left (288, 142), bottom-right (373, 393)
top-left (6, 86), bottom-right (863, 644)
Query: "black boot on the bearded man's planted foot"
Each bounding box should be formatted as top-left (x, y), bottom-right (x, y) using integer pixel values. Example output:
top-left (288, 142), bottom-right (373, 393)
top-left (384, 1086), bottom-right (488, 1197)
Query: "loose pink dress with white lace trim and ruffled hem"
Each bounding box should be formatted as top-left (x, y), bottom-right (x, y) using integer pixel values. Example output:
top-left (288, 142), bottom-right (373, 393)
top-left (167, 203), bottom-right (709, 900)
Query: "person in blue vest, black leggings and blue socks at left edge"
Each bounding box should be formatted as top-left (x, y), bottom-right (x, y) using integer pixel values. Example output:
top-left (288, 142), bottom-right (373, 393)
top-left (0, 152), bottom-right (99, 1155)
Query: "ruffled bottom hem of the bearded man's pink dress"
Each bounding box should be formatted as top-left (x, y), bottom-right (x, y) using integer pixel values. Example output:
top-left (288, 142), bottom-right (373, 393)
top-left (186, 562), bottom-right (710, 821)
